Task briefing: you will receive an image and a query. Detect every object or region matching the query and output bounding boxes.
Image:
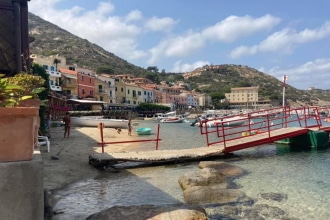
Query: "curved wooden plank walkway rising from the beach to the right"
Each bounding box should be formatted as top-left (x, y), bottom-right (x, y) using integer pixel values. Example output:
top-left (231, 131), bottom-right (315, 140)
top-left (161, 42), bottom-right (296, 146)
top-left (90, 127), bottom-right (309, 164)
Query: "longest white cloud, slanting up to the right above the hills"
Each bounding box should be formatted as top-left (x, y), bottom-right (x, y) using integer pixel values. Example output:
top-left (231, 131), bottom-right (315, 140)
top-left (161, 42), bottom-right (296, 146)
top-left (148, 15), bottom-right (280, 65)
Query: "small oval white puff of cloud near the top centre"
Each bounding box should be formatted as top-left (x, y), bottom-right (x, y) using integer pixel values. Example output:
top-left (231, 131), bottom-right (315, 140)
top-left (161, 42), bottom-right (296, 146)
top-left (145, 17), bottom-right (177, 32)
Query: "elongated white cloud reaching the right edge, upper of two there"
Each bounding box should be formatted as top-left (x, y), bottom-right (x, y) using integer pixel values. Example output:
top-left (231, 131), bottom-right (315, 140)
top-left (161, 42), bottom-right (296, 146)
top-left (230, 22), bottom-right (330, 58)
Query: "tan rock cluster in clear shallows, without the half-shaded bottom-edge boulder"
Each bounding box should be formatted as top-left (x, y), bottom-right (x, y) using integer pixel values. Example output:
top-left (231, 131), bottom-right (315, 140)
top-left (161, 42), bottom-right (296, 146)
top-left (178, 161), bottom-right (298, 220)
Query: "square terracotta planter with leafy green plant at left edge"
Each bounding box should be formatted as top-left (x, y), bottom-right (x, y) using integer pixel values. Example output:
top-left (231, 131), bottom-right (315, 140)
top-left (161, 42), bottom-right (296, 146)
top-left (0, 73), bottom-right (44, 162)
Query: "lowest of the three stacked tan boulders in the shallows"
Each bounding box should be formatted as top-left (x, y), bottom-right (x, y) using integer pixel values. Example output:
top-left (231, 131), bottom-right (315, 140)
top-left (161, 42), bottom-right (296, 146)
top-left (183, 185), bottom-right (246, 205)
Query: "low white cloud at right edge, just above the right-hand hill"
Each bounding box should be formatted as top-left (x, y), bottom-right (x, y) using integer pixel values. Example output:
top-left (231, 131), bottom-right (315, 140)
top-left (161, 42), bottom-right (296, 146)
top-left (268, 58), bottom-right (330, 89)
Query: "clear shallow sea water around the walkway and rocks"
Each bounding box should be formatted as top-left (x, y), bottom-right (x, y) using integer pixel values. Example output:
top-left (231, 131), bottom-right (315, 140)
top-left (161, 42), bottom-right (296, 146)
top-left (53, 121), bottom-right (330, 220)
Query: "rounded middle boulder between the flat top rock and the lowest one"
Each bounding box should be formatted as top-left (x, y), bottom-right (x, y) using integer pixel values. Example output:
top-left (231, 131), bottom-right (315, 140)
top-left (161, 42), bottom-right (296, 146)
top-left (178, 168), bottom-right (227, 190)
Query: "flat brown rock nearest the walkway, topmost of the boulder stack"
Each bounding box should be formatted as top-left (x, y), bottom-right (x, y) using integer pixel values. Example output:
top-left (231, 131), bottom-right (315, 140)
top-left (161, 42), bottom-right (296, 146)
top-left (198, 161), bottom-right (244, 177)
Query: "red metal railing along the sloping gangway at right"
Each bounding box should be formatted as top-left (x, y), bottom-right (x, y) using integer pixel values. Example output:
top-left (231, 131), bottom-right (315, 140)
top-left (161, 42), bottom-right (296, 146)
top-left (199, 106), bottom-right (330, 151)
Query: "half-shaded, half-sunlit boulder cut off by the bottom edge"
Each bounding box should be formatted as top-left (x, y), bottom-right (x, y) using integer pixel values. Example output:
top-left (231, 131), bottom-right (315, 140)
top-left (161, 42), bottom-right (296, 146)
top-left (87, 204), bottom-right (208, 220)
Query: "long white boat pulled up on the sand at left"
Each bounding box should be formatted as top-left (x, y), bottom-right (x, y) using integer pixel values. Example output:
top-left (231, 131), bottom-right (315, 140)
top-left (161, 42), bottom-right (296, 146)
top-left (71, 117), bottom-right (128, 129)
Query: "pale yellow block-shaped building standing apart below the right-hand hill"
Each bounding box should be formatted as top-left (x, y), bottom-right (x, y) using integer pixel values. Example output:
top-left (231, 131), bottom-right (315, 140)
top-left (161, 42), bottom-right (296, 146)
top-left (225, 87), bottom-right (259, 108)
